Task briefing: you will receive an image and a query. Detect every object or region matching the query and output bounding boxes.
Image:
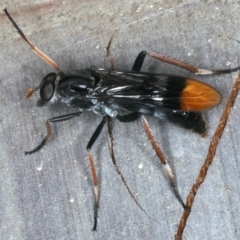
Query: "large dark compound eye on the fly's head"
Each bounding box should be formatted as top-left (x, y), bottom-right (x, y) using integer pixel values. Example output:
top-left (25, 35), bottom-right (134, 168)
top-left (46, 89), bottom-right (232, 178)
top-left (40, 73), bottom-right (57, 102)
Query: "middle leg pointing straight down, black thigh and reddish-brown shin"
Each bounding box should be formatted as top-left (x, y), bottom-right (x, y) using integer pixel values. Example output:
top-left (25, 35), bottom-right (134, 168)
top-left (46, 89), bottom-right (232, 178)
top-left (87, 116), bottom-right (108, 231)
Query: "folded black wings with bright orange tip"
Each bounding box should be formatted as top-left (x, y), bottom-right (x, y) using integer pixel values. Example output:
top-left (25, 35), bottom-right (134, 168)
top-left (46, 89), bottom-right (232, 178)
top-left (93, 69), bottom-right (221, 112)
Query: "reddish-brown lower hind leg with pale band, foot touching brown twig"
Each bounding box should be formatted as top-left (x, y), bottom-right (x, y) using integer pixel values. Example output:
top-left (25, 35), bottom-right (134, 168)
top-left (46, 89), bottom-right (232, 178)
top-left (142, 116), bottom-right (187, 209)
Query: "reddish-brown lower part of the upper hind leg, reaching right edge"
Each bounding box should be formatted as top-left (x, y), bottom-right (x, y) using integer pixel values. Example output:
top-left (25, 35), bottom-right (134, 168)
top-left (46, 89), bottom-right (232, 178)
top-left (145, 51), bottom-right (240, 75)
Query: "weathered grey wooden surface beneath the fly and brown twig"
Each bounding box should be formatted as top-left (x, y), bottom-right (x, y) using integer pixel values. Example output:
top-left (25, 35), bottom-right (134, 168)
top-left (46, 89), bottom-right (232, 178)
top-left (0, 0), bottom-right (240, 240)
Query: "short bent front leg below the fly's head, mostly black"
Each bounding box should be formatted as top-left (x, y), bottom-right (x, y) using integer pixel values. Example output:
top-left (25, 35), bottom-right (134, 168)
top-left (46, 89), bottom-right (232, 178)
top-left (25, 111), bottom-right (82, 155)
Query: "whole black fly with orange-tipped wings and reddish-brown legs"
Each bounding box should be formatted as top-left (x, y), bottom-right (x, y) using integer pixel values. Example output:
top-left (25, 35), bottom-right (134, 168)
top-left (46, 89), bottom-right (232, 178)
top-left (4, 9), bottom-right (240, 230)
